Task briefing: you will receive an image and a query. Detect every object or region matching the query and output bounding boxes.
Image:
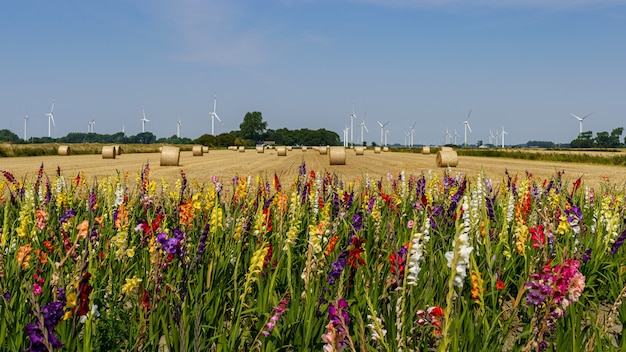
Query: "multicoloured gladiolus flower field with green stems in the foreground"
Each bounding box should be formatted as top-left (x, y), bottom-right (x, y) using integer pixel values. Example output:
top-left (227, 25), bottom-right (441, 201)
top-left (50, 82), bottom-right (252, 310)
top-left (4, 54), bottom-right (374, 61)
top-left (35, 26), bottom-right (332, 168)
top-left (0, 163), bottom-right (626, 351)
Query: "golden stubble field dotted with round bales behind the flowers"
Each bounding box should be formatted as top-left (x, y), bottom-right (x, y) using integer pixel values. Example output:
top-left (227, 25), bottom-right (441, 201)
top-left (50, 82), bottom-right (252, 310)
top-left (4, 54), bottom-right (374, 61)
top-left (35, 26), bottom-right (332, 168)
top-left (0, 149), bottom-right (626, 188)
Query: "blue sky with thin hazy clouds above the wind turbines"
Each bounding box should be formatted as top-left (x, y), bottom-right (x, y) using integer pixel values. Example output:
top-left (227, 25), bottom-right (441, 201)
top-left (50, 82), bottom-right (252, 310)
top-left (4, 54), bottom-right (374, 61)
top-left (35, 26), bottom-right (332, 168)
top-left (0, 0), bottom-right (626, 145)
